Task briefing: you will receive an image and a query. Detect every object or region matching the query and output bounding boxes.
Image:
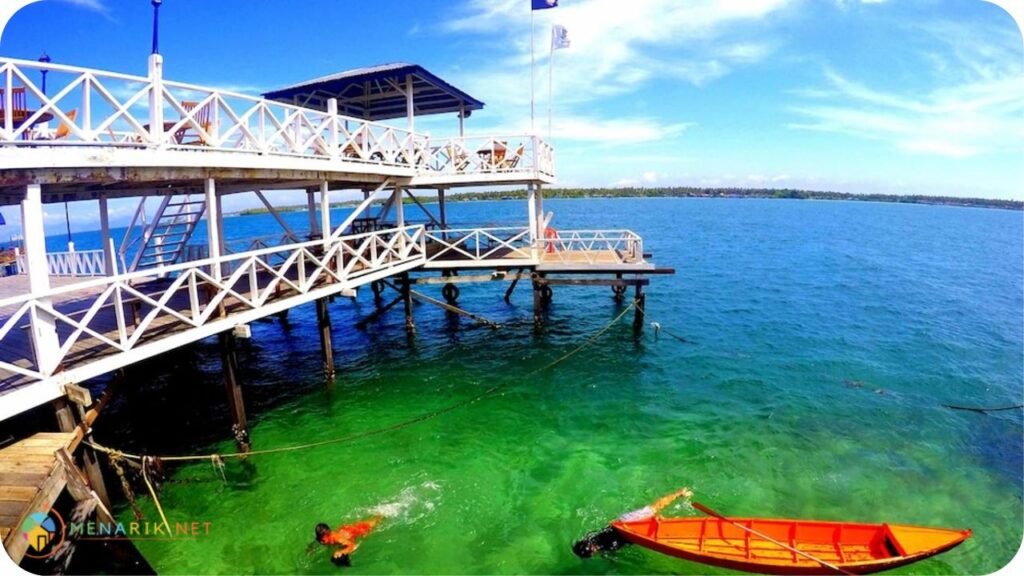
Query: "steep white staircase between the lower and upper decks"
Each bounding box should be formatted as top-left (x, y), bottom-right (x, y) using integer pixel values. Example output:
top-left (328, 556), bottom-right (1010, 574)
top-left (129, 195), bottom-right (206, 271)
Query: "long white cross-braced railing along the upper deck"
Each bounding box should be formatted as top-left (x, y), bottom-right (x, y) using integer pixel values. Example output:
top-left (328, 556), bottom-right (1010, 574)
top-left (0, 58), bottom-right (554, 176)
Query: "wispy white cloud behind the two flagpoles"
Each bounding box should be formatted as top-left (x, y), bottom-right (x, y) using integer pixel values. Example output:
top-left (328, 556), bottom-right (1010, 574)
top-left (443, 0), bottom-right (797, 141)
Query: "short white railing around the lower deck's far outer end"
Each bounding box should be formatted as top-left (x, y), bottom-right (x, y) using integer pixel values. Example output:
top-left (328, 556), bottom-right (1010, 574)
top-left (541, 229), bottom-right (644, 264)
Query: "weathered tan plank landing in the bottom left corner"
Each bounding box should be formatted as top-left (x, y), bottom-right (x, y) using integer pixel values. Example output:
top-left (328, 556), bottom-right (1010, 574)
top-left (0, 431), bottom-right (79, 564)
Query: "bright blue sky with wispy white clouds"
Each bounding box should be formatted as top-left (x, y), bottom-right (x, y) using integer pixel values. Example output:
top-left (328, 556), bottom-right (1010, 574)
top-left (0, 0), bottom-right (1024, 234)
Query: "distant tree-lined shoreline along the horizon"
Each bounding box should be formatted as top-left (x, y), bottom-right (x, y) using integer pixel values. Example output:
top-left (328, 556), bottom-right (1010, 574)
top-left (237, 187), bottom-right (1024, 216)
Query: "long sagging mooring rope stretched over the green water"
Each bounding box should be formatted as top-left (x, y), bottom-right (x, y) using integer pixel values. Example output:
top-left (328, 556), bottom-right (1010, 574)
top-left (82, 301), bottom-right (636, 463)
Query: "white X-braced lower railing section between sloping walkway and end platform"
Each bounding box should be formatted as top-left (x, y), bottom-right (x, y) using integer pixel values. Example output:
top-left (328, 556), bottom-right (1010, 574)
top-left (425, 228), bottom-right (534, 262)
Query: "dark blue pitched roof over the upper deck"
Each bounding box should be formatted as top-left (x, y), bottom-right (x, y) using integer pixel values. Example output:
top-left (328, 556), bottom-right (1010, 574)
top-left (263, 63), bottom-right (483, 120)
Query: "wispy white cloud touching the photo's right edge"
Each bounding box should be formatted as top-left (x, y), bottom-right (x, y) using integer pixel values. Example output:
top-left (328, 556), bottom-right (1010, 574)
top-left (787, 23), bottom-right (1024, 158)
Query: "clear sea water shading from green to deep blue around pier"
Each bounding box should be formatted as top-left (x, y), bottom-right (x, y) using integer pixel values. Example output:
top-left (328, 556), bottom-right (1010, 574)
top-left (96, 199), bottom-right (1024, 574)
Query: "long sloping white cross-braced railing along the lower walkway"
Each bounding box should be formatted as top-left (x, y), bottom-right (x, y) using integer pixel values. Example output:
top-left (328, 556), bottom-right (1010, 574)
top-left (0, 227), bottom-right (426, 381)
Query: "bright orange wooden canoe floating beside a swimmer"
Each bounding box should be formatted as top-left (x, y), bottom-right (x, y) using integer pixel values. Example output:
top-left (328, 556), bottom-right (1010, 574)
top-left (611, 517), bottom-right (971, 574)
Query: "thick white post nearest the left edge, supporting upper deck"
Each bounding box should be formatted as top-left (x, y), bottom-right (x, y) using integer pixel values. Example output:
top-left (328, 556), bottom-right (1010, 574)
top-left (22, 184), bottom-right (60, 375)
